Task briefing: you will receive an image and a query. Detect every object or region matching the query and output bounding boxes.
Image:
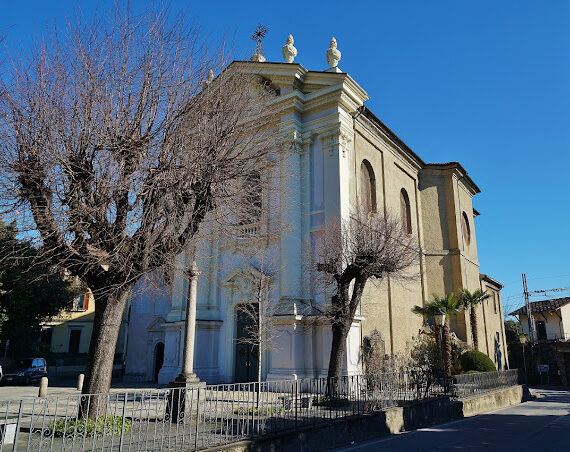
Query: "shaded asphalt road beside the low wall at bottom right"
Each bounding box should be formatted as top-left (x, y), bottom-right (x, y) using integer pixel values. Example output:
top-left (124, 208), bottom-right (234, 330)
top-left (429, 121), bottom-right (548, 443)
top-left (343, 389), bottom-right (570, 452)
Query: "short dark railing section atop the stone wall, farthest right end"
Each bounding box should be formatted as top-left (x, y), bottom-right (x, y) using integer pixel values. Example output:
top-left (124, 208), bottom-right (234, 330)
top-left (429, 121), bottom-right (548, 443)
top-left (452, 369), bottom-right (521, 398)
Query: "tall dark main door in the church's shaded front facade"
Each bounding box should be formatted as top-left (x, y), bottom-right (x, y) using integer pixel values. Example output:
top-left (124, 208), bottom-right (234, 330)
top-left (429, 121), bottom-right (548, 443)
top-left (235, 309), bottom-right (259, 383)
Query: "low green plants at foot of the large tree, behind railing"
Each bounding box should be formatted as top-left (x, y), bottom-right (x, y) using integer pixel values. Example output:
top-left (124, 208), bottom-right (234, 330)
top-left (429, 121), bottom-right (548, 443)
top-left (49, 415), bottom-right (132, 437)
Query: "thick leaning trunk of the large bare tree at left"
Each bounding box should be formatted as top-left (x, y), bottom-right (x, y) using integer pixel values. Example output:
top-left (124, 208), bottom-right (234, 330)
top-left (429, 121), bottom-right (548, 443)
top-left (81, 288), bottom-right (130, 418)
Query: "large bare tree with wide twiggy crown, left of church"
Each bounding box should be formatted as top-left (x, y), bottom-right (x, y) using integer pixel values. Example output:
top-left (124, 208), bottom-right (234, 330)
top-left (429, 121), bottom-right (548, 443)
top-left (0, 2), bottom-right (279, 412)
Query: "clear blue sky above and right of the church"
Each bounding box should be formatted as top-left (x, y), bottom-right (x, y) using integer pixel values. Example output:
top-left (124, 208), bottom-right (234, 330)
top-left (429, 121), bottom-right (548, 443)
top-left (0, 0), bottom-right (570, 311)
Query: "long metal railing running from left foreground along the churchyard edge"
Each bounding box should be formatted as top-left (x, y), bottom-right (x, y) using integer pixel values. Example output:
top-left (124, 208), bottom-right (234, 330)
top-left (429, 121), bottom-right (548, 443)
top-left (0, 371), bottom-right (512, 452)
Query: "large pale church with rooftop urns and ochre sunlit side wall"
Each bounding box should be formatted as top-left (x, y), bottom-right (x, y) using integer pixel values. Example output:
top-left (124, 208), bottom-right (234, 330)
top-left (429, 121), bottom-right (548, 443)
top-left (125, 36), bottom-right (508, 384)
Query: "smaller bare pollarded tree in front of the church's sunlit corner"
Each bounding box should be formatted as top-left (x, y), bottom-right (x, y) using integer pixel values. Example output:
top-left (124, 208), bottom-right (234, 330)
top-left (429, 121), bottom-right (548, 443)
top-left (313, 209), bottom-right (419, 377)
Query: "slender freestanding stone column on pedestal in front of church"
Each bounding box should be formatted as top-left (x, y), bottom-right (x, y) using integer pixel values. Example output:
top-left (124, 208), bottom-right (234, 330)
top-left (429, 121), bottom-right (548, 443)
top-left (171, 262), bottom-right (200, 384)
